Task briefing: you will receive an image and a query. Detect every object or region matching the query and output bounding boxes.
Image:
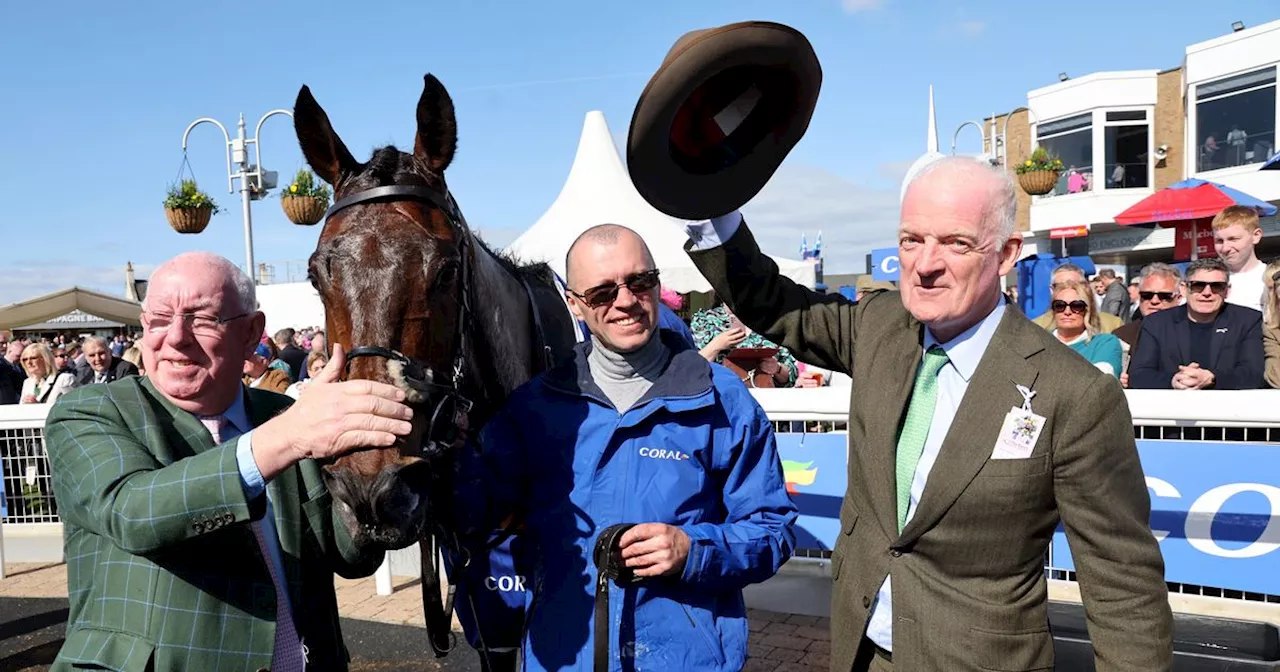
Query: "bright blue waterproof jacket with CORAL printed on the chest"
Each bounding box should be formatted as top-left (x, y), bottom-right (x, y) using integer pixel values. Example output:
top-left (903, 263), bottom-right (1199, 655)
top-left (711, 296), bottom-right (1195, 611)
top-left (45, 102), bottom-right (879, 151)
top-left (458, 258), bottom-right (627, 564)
top-left (481, 330), bottom-right (796, 672)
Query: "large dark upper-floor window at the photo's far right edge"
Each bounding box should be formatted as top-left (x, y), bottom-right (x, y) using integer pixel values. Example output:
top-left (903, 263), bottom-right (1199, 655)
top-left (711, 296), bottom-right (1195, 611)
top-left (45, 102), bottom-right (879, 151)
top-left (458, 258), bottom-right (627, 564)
top-left (1196, 68), bottom-right (1276, 172)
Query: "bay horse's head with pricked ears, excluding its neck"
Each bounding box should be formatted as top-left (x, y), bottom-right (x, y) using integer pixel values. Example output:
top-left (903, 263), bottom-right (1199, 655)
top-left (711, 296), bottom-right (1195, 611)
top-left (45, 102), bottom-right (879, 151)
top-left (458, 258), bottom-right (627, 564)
top-left (293, 74), bottom-right (471, 548)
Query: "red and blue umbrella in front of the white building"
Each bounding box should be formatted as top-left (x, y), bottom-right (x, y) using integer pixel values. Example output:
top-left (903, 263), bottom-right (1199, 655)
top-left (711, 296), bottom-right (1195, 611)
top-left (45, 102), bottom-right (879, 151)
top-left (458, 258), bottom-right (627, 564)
top-left (1116, 178), bottom-right (1276, 260)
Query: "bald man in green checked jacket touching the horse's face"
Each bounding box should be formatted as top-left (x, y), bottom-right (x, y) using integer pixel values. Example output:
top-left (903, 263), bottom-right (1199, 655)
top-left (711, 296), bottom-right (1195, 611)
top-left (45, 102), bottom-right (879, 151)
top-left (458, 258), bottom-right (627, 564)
top-left (46, 252), bottom-right (410, 672)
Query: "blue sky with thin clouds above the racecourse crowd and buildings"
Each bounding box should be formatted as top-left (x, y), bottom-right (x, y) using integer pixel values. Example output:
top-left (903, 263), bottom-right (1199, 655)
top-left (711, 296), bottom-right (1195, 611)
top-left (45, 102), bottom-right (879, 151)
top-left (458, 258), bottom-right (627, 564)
top-left (0, 0), bottom-right (1280, 303)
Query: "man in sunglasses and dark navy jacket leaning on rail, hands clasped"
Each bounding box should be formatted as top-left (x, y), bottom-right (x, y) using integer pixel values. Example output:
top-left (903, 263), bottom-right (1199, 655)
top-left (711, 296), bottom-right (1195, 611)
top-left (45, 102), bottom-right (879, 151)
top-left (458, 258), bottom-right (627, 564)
top-left (1129, 259), bottom-right (1266, 389)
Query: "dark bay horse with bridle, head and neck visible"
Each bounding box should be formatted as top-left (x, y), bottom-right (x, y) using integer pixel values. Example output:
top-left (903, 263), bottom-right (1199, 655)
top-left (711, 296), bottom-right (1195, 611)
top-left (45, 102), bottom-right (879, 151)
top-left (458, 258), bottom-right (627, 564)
top-left (293, 74), bottom-right (576, 655)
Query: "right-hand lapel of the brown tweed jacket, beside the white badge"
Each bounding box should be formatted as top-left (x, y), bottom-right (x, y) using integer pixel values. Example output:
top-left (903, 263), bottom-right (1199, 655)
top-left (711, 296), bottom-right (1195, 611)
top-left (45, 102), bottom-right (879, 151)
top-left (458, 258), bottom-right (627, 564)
top-left (882, 310), bottom-right (1044, 548)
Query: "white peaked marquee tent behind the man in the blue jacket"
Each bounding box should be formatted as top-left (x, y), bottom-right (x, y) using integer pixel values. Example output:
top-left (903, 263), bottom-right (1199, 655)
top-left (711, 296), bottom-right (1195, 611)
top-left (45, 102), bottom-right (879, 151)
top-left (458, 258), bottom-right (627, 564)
top-left (507, 111), bottom-right (815, 292)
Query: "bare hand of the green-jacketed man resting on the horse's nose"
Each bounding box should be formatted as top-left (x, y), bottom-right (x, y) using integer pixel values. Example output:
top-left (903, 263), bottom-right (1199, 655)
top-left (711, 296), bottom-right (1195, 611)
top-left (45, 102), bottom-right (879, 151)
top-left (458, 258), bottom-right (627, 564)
top-left (253, 344), bottom-right (413, 480)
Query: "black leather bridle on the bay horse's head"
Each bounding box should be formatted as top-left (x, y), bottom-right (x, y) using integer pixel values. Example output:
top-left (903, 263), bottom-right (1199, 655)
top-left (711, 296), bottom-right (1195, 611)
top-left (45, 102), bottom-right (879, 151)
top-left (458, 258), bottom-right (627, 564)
top-left (325, 184), bottom-right (475, 457)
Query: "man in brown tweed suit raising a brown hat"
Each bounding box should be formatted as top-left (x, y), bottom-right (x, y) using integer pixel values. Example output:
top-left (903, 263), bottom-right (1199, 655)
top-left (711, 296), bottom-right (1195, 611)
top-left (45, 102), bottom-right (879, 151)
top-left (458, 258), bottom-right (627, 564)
top-left (627, 18), bottom-right (1172, 672)
